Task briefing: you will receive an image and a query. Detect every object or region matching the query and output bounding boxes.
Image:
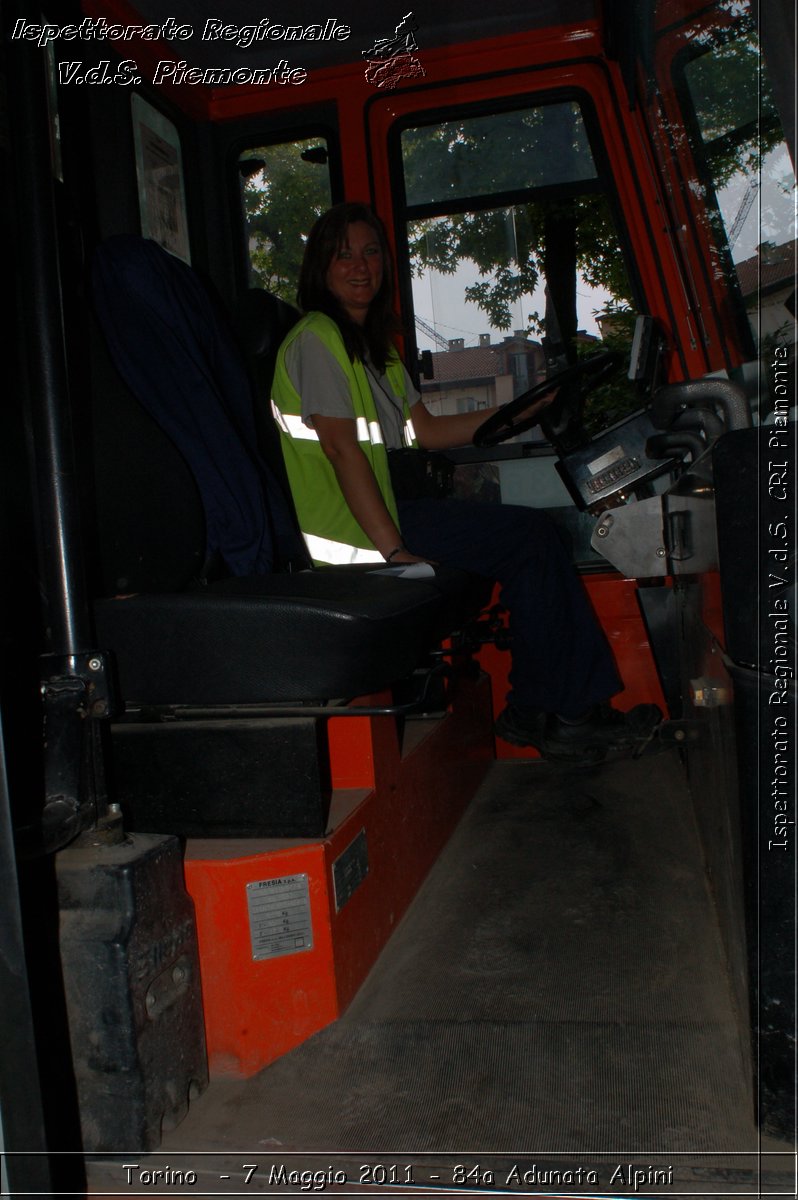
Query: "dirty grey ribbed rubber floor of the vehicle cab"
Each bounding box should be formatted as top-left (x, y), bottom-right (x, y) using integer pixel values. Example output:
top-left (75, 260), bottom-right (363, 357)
top-left (163, 755), bottom-right (756, 1166)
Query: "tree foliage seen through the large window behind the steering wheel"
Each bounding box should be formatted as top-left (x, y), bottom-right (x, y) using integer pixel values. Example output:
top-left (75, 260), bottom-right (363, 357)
top-left (402, 103), bottom-right (630, 334)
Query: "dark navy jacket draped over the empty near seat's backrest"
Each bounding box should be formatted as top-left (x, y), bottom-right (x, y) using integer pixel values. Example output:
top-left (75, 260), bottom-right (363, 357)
top-left (94, 235), bottom-right (306, 590)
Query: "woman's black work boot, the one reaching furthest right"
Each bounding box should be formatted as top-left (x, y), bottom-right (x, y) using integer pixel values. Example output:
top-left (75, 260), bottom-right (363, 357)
top-left (538, 703), bottom-right (662, 764)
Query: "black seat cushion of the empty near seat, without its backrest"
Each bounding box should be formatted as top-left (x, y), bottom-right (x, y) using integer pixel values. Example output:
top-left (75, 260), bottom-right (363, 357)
top-left (95, 570), bottom-right (474, 706)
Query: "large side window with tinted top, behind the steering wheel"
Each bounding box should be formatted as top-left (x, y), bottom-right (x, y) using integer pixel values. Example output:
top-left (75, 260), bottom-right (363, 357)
top-left (401, 100), bottom-right (641, 440)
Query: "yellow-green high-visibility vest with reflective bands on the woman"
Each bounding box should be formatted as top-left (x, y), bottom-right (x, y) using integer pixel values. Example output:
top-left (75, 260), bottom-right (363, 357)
top-left (271, 312), bottom-right (416, 564)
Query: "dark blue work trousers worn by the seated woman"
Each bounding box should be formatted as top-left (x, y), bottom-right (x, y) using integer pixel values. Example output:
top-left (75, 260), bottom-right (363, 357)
top-left (398, 499), bottom-right (622, 716)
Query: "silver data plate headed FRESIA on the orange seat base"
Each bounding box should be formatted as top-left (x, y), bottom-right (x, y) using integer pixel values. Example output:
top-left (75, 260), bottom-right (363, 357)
top-left (247, 875), bottom-right (313, 960)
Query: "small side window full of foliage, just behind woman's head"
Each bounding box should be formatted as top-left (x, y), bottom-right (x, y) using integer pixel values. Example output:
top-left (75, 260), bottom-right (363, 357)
top-left (238, 138), bottom-right (332, 304)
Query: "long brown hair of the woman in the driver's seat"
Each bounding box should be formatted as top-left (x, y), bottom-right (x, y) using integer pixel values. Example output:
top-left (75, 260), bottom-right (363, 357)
top-left (296, 202), bottom-right (400, 371)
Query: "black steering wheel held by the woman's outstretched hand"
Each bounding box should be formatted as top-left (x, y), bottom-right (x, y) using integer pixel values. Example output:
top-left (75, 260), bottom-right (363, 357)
top-left (473, 350), bottom-right (624, 446)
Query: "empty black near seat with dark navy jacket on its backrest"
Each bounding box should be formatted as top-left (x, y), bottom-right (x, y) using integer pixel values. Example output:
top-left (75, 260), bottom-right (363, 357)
top-left (94, 236), bottom-right (482, 707)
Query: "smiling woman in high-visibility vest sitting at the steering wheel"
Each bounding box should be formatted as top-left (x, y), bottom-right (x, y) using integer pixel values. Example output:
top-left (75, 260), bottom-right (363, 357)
top-left (272, 196), bottom-right (661, 763)
